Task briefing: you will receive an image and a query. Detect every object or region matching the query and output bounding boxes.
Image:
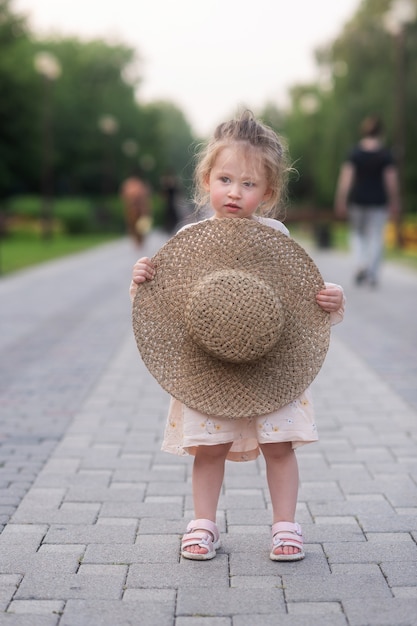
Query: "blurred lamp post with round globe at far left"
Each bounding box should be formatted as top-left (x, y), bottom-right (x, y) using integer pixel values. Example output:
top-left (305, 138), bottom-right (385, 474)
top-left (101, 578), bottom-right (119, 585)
top-left (34, 52), bottom-right (61, 240)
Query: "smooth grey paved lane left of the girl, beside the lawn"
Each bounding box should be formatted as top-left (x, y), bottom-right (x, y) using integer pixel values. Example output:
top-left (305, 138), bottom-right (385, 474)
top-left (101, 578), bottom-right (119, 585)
top-left (0, 234), bottom-right (165, 529)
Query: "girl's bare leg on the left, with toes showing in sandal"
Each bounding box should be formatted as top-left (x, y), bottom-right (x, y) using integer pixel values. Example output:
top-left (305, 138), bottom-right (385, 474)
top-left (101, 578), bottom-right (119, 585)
top-left (186, 443), bottom-right (232, 554)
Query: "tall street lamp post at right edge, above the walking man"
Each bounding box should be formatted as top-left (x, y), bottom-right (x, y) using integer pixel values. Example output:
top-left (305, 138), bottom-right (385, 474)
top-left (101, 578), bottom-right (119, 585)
top-left (384, 0), bottom-right (415, 247)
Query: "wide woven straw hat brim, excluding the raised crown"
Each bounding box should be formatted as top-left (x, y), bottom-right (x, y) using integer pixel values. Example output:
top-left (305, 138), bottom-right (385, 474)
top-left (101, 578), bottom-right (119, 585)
top-left (132, 218), bottom-right (330, 419)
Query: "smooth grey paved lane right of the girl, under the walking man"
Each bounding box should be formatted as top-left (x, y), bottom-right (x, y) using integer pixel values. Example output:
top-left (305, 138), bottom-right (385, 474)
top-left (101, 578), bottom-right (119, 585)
top-left (311, 250), bottom-right (417, 408)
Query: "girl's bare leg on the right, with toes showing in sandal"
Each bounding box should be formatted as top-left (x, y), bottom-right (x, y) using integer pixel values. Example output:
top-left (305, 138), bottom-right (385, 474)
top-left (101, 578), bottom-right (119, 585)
top-left (260, 442), bottom-right (299, 554)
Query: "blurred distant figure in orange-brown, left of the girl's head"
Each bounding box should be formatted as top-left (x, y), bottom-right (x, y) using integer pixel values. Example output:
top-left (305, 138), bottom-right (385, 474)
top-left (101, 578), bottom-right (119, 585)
top-left (120, 171), bottom-right (152, 245)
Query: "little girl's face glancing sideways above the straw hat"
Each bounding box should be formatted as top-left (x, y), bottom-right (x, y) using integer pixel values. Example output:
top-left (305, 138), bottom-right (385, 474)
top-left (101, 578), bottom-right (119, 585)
top-left (205, 146), bottom-right (271, 219)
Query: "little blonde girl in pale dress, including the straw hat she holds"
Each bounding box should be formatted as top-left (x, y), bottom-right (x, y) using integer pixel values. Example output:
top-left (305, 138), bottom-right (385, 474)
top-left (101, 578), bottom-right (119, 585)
top-left (130, 111), bottom-right (344, 561)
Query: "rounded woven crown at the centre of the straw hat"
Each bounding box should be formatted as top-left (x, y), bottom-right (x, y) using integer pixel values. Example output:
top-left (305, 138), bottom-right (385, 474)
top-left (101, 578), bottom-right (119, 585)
top-left (185, 269), bottom-right (285, 364)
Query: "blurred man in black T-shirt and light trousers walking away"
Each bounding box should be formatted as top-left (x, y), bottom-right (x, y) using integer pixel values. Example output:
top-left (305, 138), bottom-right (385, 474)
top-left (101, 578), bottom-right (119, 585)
top-left (335, 116), bottom-right (400, 287)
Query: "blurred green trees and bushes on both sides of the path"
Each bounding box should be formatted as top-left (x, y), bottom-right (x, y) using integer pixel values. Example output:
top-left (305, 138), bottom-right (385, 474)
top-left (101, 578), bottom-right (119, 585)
top-left (0, 0), bottom-right (417, 250)
